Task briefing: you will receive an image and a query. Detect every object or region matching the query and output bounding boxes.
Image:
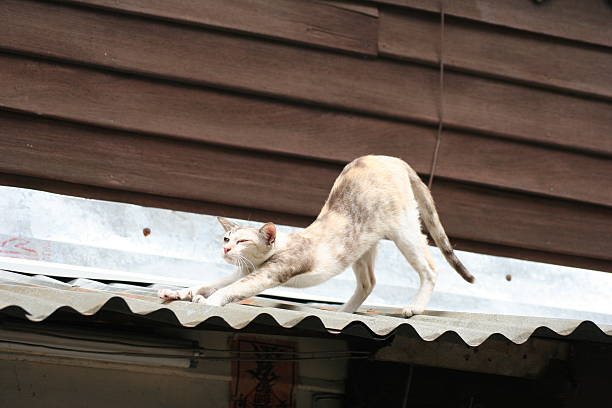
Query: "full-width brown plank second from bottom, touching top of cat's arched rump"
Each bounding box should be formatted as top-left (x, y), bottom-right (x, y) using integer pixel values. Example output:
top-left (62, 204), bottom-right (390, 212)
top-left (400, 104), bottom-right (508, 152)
top-left (0, 52), bottom-right (612, 205)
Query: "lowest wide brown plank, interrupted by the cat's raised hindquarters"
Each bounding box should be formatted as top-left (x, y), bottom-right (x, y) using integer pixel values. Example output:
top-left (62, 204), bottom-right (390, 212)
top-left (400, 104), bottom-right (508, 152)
top-left (0, 113), bottom-right (612, 261)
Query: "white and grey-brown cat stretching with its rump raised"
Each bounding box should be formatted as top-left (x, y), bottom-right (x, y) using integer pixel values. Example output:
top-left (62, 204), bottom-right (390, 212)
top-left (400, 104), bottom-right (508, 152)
top-left (159, 155), bottom-right (475, 317)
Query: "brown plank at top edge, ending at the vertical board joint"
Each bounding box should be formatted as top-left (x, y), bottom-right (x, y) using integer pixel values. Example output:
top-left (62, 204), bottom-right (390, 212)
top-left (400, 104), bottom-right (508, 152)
top-left (55, 0), bottom-right (378, 55)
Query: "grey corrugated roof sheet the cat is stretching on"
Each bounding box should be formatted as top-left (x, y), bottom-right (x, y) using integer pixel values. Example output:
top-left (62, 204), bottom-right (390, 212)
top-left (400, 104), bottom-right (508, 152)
top-left (0, 271), bottom-right (612, 346)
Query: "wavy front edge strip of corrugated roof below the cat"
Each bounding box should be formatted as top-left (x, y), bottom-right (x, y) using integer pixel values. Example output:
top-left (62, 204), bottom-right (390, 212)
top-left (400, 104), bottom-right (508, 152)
top-left (0, 283), bottom-right (612, 346)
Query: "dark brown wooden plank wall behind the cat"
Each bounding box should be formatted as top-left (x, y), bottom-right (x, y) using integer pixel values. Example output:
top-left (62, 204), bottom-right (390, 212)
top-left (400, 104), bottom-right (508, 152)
top-left (0, 0), bottom-right (612, 271)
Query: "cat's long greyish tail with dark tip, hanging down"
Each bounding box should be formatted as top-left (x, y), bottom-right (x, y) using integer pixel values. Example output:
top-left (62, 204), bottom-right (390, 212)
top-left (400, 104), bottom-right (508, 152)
top-left (408, 168), bottom-right (476, 283)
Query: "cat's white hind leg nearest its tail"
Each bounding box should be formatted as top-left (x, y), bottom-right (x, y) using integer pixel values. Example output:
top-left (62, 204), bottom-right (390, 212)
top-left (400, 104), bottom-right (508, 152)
top-left (393, 228), bottom-right (438, 317)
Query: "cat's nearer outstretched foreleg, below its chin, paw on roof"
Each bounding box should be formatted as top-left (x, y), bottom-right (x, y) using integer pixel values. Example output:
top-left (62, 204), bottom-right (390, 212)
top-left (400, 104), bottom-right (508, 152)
top-left (193, 265), bottom-right (288, 306)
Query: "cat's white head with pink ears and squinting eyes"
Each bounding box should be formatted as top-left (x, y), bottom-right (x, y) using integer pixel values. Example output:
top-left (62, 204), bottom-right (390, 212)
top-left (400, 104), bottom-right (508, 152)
top-left (217, 217), bottom-right (276, 270)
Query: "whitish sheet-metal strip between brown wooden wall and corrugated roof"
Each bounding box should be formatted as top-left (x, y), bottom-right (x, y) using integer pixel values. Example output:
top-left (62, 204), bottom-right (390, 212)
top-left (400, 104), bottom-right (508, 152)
top-left (0, 186), bottom-right (612, 324)
